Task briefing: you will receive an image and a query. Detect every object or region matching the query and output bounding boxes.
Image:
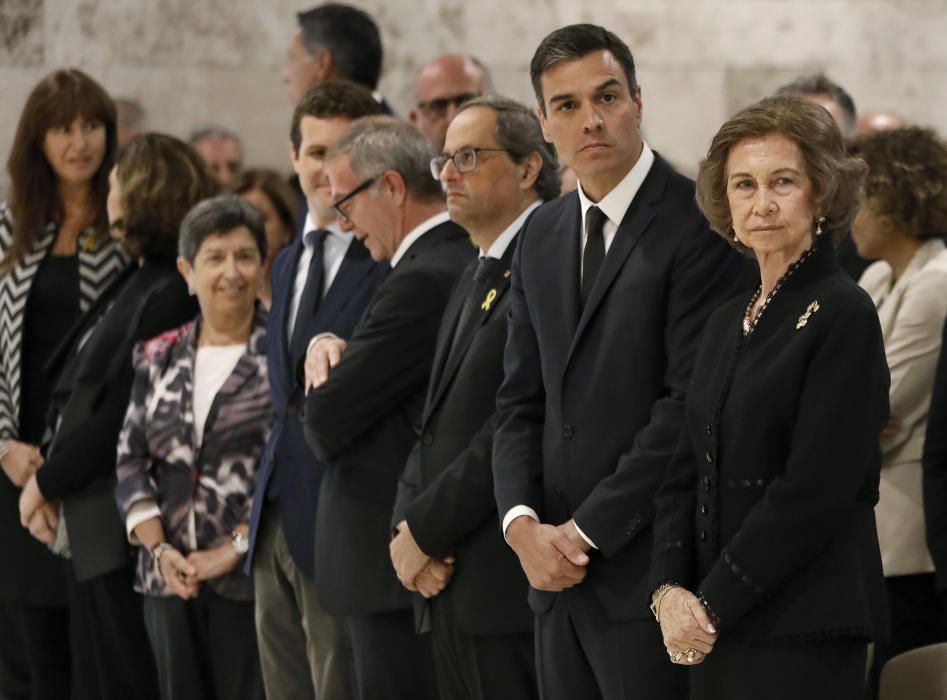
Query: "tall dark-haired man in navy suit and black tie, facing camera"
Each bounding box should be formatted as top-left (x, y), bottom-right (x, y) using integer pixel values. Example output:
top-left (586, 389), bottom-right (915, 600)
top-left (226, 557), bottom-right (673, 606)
top-left (493, 25), bottom-right (752, 700)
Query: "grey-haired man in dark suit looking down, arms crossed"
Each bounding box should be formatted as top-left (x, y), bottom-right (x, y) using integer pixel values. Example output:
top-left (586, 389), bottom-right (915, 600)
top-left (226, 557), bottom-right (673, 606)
top-left (304, 117), bottom-right (474, 700)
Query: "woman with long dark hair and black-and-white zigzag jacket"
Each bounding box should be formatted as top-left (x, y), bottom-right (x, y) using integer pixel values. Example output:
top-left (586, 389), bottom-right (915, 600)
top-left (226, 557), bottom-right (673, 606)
top-left (0, 70), bottom-right (127, 698)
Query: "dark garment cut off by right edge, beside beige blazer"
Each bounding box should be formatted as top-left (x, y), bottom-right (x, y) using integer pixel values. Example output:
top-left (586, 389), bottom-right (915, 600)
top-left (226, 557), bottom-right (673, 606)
top-left (922, 324), bottom-right (947, 591)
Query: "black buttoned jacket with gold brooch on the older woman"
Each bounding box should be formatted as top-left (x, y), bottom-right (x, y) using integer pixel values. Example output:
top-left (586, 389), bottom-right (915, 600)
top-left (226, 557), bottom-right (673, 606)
top-left (641, 241), bottom-right (889, 641)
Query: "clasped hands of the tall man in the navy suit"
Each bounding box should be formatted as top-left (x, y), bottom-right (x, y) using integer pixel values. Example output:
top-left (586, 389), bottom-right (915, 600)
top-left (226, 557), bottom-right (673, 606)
top-left (506, 515), bottom-right (591, 591)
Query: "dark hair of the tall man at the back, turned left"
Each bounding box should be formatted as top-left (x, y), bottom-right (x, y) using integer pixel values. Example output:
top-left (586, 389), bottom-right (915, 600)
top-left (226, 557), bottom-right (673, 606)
top-left (296, 2), bottom-right (382, 90)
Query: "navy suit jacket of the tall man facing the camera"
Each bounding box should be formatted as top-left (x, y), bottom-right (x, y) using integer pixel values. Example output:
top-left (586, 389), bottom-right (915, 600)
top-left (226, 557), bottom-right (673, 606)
top-left (493, 156), bottom-right (751, 620)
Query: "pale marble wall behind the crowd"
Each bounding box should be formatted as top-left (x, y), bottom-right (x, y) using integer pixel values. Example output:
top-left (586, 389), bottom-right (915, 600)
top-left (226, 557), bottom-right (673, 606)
top-left (0, 0), bottom-right (947, 191)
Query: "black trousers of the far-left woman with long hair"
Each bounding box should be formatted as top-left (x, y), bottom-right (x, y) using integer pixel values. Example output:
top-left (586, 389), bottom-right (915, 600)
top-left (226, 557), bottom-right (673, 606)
top-left (0, 601), bottom-right (71, 700)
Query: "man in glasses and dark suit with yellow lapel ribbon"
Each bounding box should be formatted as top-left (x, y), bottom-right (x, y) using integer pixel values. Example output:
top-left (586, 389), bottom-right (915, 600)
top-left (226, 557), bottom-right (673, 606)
top-left (390, 97), bottom-right (560, 700)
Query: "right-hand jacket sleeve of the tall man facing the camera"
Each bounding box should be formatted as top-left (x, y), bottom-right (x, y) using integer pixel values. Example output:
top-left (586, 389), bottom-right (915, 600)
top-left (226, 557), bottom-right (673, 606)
top-left (573, 219), bottom-right (751, 557)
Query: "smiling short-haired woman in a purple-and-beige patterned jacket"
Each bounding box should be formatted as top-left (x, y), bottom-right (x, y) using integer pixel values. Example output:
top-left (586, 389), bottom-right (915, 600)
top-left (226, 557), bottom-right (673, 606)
top-left (116, 195), bottom-right (272, 700)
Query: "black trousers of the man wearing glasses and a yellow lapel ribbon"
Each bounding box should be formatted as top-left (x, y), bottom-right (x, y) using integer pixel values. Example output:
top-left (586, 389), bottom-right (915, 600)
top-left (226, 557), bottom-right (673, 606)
top-left (429, 598), bottom-right (539, 700)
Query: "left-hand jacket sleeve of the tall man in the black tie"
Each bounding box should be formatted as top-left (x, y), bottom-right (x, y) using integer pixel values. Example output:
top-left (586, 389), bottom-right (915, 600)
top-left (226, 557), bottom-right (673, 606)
top-left (493, 230), bottom-right (546, 520)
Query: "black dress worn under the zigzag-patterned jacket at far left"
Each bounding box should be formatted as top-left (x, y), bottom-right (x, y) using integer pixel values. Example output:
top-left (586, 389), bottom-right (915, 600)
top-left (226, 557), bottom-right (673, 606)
top-left (0, 255), bottom-right (79, 698)
